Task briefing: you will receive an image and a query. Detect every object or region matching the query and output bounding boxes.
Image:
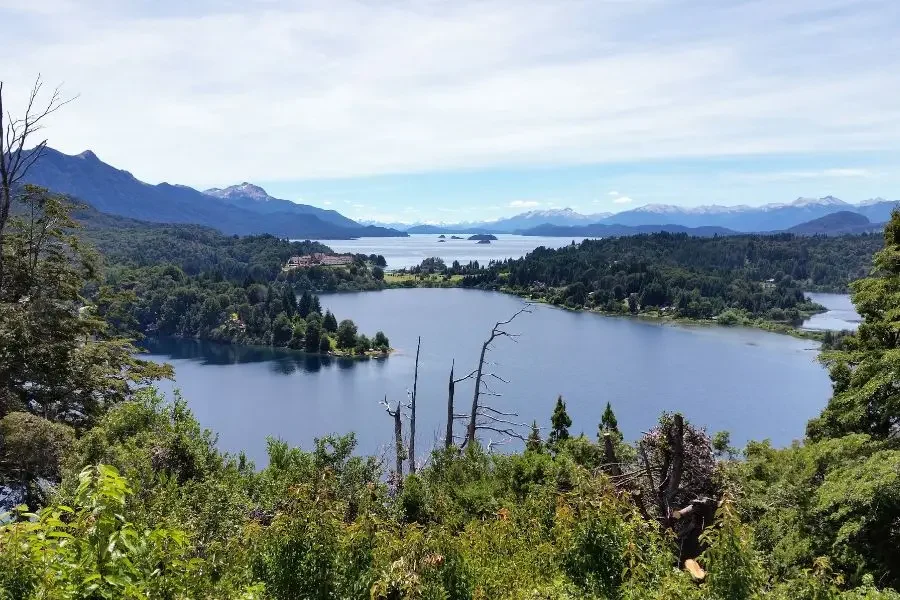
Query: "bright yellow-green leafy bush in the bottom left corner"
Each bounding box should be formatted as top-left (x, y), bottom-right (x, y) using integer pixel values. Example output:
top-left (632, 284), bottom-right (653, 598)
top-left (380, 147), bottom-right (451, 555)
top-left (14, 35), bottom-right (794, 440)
top-left (0, 465), bottom-right (223, 599)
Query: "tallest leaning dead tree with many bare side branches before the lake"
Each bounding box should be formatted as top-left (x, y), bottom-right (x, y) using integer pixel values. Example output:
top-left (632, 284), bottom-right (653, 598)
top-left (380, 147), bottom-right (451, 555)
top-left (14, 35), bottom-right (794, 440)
top-left (454, 305), bottom-right (531, 446)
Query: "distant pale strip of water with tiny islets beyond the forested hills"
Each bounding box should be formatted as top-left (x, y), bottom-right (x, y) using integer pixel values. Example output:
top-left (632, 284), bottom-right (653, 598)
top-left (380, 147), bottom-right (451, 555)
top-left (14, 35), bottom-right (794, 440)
top-left (310, 233), bottom-right (583, 269)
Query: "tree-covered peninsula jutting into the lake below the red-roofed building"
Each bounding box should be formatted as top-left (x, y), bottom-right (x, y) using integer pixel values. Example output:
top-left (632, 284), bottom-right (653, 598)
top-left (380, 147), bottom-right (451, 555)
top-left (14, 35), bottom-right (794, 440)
top-left (98, 265), bottom-right (390, 354)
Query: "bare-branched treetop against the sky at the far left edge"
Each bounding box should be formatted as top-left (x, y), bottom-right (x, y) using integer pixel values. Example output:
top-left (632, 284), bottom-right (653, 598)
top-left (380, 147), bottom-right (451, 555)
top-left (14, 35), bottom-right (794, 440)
top-left (0, 75), bottom-right (75, 276)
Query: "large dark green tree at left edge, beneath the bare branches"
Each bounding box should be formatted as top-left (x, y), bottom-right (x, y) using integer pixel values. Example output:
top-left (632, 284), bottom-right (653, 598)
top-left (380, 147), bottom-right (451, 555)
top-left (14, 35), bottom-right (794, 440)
top-left (0, 185), bottom-right (171, 427)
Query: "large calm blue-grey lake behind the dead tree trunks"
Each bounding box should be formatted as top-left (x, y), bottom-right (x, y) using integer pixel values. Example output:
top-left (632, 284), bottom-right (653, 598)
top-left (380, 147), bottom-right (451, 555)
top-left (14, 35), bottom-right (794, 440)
top-left (144, 289), bottom-right (830, 464)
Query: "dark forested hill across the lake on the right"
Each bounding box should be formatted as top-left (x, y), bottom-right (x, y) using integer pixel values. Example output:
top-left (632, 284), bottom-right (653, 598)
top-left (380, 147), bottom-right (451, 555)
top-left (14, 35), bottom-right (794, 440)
top-left (463, 233), bottom-right (883, 321)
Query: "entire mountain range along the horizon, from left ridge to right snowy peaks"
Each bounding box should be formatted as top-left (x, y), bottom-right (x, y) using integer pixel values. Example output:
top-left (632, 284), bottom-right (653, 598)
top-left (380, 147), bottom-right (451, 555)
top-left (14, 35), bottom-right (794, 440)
top-left (17, 148), bottom-right (898, 239)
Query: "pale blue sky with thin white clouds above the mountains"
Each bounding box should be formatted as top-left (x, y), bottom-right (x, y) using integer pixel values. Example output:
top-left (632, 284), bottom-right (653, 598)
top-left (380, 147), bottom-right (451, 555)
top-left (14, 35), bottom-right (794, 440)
top-left (0, 0), bottom-right (900, 222)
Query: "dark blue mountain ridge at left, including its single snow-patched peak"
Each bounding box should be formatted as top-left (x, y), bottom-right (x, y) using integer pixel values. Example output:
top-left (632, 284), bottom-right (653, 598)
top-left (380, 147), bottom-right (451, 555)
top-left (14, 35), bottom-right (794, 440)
top-left (26, 148), bottom-right (407, 239)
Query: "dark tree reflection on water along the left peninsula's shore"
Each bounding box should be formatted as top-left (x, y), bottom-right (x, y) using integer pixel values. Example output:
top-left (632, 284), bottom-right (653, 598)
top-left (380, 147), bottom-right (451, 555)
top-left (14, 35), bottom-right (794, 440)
top-left (140, 337), bottom-right (370, 375)
